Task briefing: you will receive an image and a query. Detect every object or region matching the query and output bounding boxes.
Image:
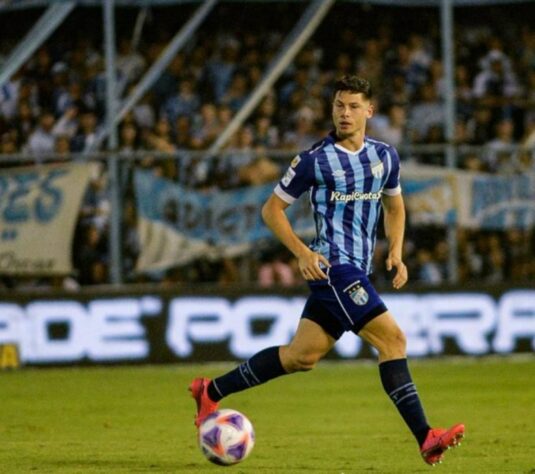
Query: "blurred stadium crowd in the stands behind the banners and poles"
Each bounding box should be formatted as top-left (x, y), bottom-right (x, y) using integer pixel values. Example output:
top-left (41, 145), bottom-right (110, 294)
top-left (0, 3), bottom-right (535, 288)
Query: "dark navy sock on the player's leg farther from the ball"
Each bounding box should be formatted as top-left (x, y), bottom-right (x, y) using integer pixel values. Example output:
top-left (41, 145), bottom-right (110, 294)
top-left (379, 359), bottom-right (430, 446)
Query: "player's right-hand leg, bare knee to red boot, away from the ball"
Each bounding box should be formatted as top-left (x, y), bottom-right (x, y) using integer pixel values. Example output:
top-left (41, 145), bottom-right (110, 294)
top-left (358, 311), bottom-right (464, 464)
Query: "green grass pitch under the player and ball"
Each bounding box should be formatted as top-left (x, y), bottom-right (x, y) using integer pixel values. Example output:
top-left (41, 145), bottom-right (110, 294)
top-left (0, 355), bottom-right (535, 474)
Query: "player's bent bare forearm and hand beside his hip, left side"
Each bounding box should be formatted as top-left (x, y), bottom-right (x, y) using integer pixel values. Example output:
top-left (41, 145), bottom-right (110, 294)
top-left (262, 194), bottom-right (330, 280)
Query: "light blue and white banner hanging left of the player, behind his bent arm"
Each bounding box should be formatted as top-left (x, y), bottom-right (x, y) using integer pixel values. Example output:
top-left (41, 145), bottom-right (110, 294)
top-left (134, 170), bottom-right (314, 272)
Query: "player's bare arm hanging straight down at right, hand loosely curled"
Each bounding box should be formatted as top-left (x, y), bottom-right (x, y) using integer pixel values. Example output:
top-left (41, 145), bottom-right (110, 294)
top-left (382, 194), bottom-right (408, 289)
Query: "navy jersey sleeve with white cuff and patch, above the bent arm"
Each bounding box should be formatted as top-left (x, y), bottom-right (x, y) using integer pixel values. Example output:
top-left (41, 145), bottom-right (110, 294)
top-left (274, 153), bottom-right (314, 204)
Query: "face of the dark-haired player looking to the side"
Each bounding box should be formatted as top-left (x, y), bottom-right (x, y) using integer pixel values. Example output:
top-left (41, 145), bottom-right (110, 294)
top-left (333, 91), bottom-right (373, 138)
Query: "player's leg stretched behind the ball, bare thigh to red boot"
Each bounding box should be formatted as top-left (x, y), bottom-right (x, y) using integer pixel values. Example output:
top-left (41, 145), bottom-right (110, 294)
top-left (190, 318), bottom-right (335, 426)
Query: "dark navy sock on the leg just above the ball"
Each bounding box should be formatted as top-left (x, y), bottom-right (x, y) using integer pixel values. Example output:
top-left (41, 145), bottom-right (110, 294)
top-left (208, 346), bottom-right (286, 402)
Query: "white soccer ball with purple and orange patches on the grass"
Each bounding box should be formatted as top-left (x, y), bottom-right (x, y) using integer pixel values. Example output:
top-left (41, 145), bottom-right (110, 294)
top-left (199, 408), bottom-right (255, 466)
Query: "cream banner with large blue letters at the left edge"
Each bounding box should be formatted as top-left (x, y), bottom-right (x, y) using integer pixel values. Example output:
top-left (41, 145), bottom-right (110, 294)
top-left (0, 164), bottom-right (95, 275)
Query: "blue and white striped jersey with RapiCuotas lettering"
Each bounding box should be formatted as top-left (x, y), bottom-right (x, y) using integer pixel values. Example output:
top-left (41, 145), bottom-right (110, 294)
top-left (274, 133), bottom-right (401, 273)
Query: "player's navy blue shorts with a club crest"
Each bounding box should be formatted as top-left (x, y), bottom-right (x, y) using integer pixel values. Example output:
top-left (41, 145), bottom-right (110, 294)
top-left (301, 264), bottom-right (387, 339)
